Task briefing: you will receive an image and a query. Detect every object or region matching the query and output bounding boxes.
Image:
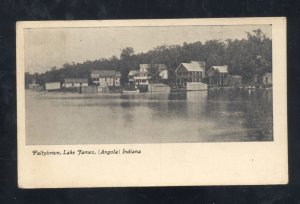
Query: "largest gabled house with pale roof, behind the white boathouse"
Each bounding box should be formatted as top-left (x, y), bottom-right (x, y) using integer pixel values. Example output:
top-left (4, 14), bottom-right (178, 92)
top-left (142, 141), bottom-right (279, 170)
top-left (175, 61), bottom-right (205, 85)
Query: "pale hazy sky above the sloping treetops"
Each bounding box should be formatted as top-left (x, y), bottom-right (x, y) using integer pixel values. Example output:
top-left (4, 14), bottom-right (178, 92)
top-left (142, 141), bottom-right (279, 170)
top-left (24, 25), bottom-right (272, 73)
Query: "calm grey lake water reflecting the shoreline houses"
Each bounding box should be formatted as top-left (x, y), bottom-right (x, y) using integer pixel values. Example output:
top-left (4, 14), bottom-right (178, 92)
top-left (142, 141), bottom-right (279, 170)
top-left (25, 89), bottom-right (273, 145)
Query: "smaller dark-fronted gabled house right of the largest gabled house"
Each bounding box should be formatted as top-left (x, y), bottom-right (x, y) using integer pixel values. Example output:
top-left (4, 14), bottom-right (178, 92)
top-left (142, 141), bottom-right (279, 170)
top-left (207, 65), bottom-right (228, 85)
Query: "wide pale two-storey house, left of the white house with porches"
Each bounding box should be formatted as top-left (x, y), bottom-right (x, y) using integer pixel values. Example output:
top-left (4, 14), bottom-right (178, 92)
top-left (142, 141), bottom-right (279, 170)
top-left (91, 70), bottom-right (121, 86)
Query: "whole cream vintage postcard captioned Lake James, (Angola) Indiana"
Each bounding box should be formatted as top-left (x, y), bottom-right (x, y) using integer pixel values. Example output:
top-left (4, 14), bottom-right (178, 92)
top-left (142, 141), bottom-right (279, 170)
top-left (16, 17), bottom-right (288, 188)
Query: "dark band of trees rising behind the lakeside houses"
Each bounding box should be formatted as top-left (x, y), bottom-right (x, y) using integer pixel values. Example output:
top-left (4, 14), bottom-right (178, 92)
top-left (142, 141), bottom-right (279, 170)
top-left (25, 29), bottom-right (272, 85)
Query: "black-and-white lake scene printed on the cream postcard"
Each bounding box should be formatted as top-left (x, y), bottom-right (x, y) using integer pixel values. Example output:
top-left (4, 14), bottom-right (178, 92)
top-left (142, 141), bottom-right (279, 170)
top-left (24, 21), bottom-right (274, 145)
